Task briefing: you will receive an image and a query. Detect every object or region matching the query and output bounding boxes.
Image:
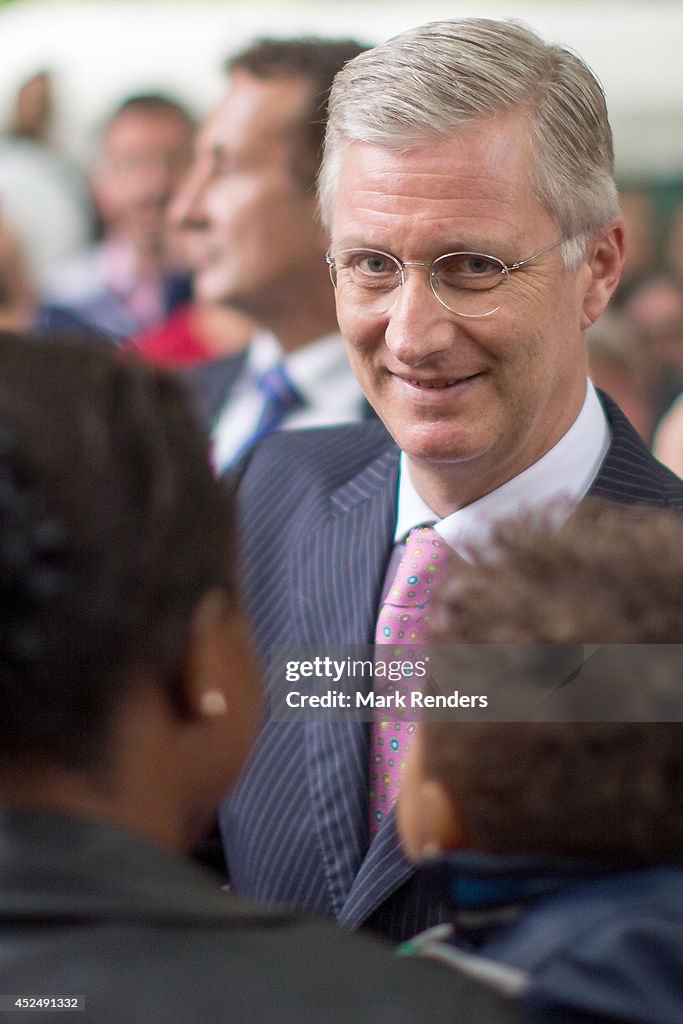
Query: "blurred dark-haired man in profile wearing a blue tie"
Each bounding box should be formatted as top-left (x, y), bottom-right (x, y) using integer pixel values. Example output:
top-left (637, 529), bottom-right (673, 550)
top-left (171, 38), bottom-right (368, 470)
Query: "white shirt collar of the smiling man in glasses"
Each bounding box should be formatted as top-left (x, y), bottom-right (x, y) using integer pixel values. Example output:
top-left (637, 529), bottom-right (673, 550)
top-left (394, 381), bottom-right (610, 555)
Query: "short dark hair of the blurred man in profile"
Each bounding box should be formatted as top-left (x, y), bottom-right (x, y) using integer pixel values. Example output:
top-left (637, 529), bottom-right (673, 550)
top-left (225, 36), bottom-right (367, 188)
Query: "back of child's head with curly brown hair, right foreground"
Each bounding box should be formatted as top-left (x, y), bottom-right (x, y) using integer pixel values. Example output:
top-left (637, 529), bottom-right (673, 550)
top-left (402, 502), bottom-right (683, 864)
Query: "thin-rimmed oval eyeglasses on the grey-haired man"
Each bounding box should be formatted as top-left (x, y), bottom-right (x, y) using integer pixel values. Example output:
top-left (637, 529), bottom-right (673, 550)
top-left (326, 239), bottom-right (566, 316)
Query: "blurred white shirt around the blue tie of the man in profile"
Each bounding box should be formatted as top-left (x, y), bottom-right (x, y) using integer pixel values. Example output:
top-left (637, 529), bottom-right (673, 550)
top-left (212, 332), bottom-right (364, 471)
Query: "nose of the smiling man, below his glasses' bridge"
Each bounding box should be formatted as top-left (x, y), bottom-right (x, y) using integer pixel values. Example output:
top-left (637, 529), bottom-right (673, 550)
top-left (384, 263), bottom-right (457, 367)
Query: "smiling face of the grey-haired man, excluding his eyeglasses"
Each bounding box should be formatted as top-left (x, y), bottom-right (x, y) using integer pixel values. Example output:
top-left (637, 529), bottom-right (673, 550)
top-left (332, 115), bottom-right (615, 515)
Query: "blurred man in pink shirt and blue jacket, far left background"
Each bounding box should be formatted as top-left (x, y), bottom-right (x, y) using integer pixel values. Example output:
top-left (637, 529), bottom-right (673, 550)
top-left (38, 93), bottom-right (195, 343)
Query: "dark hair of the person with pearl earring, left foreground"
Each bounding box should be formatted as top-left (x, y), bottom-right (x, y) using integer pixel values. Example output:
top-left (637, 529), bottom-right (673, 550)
top-left (0, 334), bottom-right (250, 776)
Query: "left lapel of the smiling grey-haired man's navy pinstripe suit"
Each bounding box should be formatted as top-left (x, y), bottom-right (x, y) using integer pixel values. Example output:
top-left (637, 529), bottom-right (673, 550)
top-left (293, 446), bottom-right (398, 913)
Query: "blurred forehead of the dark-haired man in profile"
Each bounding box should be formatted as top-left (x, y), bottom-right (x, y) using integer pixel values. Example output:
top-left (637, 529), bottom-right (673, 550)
top-left (199, 70), bottom-right (311, 150)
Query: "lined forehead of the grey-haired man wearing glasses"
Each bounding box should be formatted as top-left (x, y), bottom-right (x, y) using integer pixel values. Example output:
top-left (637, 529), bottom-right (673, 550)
top-left (333, 115), bottom-right (552, 251)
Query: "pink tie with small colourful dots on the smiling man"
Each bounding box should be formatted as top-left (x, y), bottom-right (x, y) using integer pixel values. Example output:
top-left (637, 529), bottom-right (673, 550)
top-left (370, 526), bottom-right (451, 842)
